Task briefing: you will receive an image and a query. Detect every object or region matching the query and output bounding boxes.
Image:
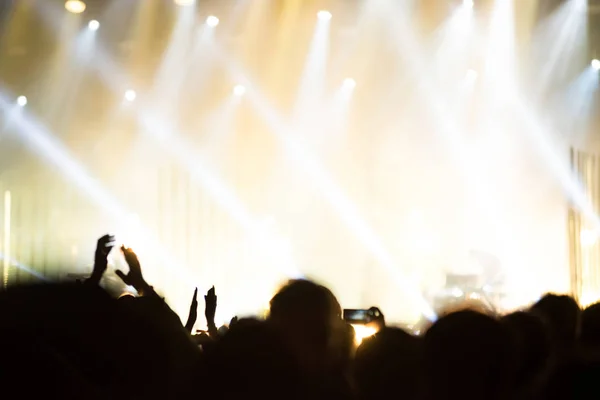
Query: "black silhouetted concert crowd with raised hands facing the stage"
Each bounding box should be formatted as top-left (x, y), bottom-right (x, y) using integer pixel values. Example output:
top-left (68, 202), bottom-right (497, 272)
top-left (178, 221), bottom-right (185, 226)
top-left (0, 235), bottom-right (600, 400)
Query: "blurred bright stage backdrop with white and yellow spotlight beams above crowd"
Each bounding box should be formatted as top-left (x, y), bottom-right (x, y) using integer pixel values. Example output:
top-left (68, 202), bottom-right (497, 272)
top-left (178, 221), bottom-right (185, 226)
top-left (0, 0), bottom-right (600, 322)
